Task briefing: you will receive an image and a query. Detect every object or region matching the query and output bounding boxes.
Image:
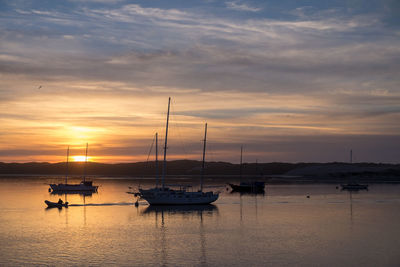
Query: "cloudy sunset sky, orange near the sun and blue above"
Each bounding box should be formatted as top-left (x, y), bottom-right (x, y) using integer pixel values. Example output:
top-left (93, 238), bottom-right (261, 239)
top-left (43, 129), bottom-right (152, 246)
top-left (0, 0), bottom-right (400, 163)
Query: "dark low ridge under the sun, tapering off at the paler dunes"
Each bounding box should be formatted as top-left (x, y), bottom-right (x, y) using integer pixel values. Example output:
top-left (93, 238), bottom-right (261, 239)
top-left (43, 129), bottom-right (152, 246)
top-left (0, 160), bottom-right (301, 176)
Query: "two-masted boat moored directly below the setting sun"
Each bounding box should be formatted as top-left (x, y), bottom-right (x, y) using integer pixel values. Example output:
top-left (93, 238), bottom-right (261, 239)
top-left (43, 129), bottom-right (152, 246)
top-left (50, 143), bottom-right (98, 193)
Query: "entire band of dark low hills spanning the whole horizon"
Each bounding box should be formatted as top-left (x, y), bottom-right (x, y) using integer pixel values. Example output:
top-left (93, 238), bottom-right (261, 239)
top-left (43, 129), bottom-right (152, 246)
top-left (0, 160), bottom-right (400, 182)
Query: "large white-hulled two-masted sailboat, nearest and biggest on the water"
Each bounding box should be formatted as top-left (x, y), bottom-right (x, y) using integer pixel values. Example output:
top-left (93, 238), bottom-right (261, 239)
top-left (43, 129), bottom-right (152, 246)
top-left (137, 98), bottom-right (219, 205)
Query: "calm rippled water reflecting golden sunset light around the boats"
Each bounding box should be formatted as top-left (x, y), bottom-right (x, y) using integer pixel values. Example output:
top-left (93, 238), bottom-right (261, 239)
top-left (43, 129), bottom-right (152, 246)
top-left (0, 177), bottom-right (400, 266)
